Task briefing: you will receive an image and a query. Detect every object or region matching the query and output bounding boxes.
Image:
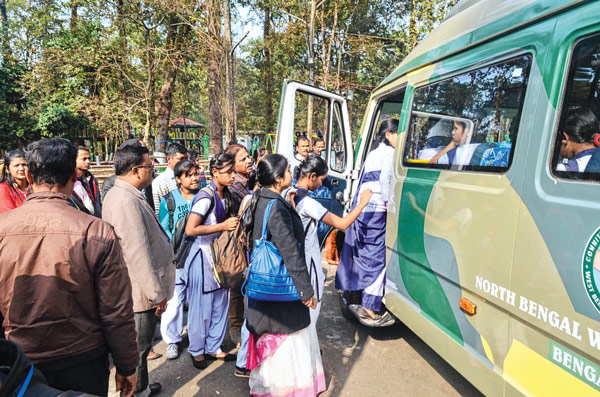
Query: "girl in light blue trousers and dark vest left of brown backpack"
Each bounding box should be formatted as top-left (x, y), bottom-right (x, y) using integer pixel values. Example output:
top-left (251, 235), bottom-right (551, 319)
top-left (184, 153), bottom-right (239, 369)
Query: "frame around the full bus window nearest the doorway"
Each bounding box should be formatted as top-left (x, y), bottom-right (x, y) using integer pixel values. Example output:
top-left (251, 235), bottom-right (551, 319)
top-left (401, 51), bottom-right (536, 175)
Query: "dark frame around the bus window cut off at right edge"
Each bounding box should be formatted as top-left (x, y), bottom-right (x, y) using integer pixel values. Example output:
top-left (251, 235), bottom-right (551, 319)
top-left (546, 31), bottom-right (600, 184)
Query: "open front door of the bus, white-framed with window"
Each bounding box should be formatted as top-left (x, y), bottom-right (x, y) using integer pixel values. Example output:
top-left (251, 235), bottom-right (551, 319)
top-left (276, 80), bottom-right (353, 241)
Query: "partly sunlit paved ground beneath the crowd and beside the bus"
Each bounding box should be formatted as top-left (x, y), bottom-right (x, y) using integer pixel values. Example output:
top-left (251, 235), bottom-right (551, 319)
top-left (110, 265), bottom-right (480, 397)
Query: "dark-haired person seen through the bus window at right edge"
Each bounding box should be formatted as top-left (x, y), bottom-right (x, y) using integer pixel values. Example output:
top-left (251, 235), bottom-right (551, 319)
top-left (556, 106), bottom-right (600, 172)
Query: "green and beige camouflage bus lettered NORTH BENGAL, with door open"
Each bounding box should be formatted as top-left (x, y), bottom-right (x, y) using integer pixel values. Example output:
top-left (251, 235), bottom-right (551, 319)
top-left (276, 0), bottom-right (600, 396)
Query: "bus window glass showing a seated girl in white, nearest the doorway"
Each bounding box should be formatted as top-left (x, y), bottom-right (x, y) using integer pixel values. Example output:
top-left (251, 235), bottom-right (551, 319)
top-left (403, 55), bottom-right (531, 172)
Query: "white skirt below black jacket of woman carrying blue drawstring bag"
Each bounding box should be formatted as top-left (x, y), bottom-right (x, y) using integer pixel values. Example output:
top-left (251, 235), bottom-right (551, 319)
top-left (250, 322), bottom-right (326, 397)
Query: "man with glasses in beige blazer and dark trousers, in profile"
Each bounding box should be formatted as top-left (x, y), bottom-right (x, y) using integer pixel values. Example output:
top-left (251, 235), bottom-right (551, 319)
top-left (102, 140), bottom-right (175, 395)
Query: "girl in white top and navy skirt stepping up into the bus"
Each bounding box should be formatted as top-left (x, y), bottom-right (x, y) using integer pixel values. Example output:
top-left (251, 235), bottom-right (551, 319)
top-left (335, 119), bottom-right (398, 326)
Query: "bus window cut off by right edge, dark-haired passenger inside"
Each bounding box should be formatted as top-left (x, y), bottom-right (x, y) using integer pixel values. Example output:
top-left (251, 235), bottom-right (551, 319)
top-left (551, 35), bottom-right (600, 181)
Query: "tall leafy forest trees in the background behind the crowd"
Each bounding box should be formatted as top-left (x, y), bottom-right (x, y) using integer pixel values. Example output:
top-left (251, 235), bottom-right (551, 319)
top-left (0, 0), bottom-right (455, 150)
